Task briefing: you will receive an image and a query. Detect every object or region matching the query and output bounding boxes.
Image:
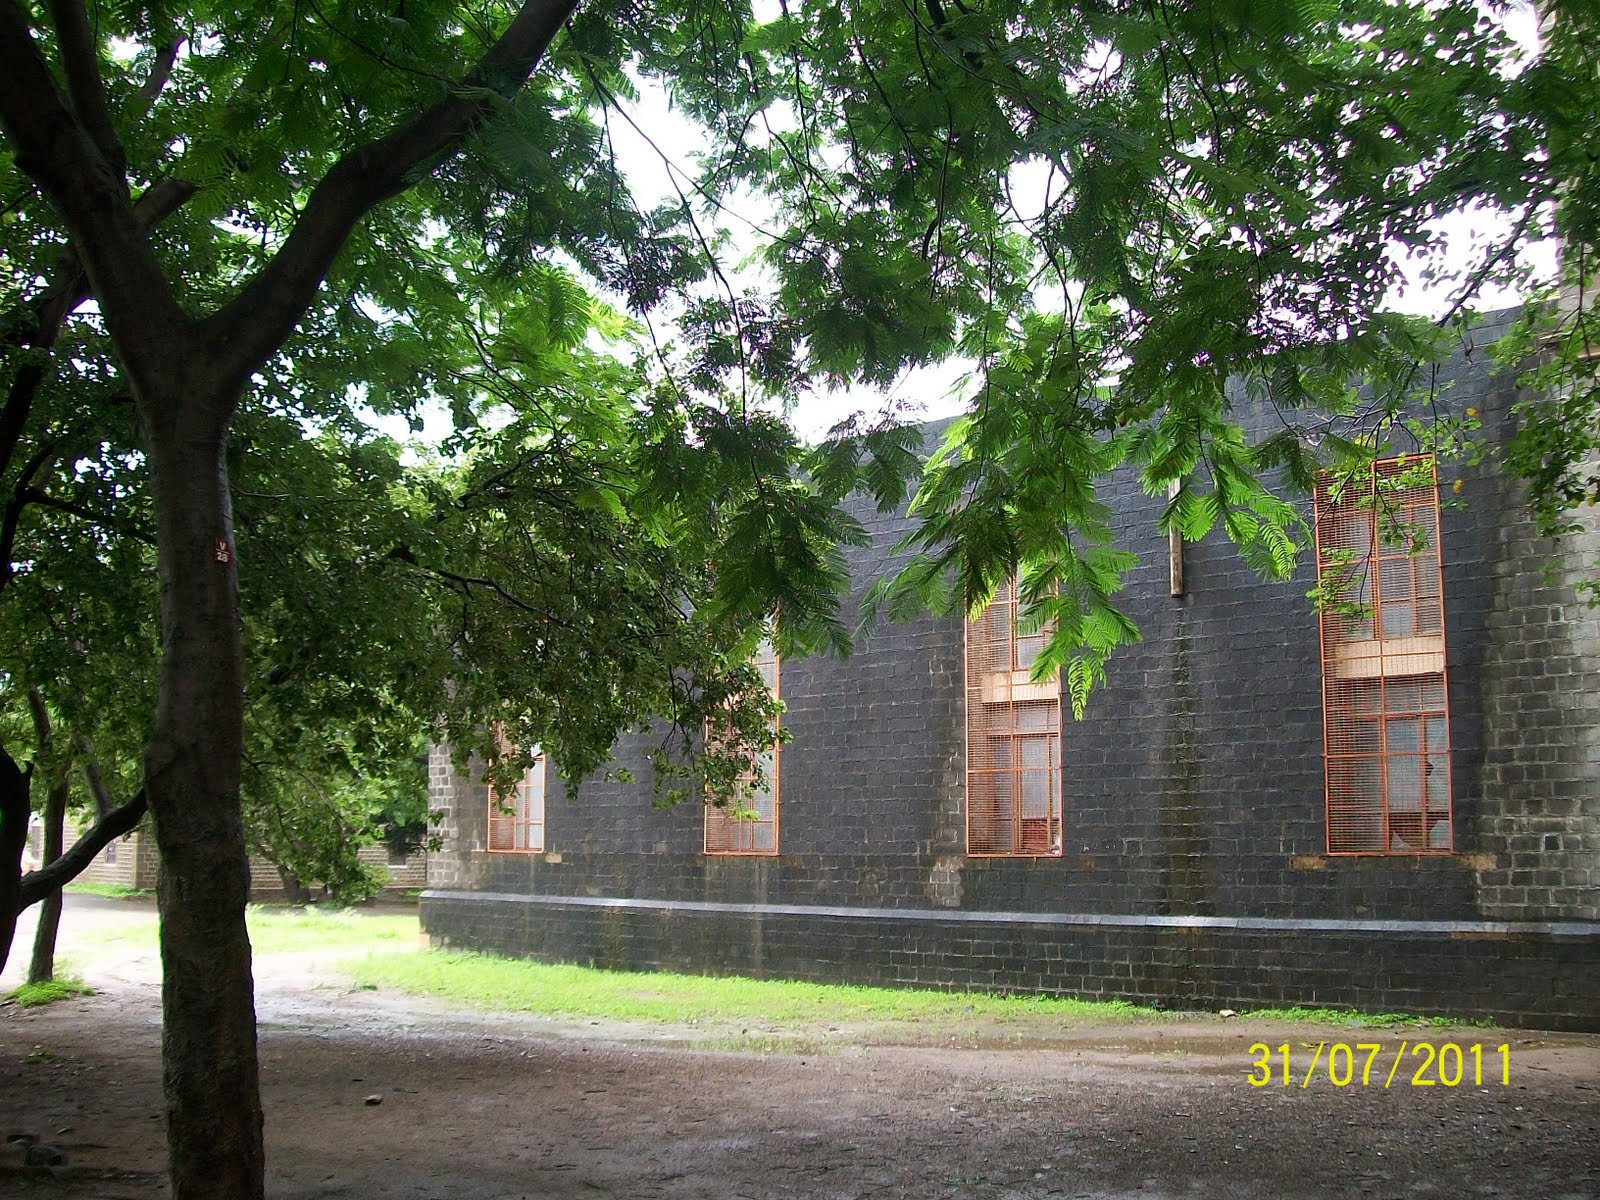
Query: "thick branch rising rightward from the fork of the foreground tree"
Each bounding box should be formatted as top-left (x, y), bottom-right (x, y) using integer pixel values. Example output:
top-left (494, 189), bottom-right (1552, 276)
top-left (201, 0), bottom-right (579, 395)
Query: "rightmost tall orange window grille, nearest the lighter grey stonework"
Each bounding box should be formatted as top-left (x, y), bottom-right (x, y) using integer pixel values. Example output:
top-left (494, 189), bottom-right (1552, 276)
top-left (1315, 456), bottom-right (1454, 854)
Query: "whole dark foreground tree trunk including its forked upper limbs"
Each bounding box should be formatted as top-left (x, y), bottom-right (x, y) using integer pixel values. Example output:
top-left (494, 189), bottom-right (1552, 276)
top-left (0, 11), bottom-right (578, 1200)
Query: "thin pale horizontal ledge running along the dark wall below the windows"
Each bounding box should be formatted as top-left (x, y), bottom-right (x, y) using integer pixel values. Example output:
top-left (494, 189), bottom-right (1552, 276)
top-left (422, 888), bottom-right (1600, 942)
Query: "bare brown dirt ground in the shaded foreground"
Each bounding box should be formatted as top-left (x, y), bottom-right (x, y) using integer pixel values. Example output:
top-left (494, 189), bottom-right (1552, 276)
top-left (0, 902), bottom-right (1600, 1200)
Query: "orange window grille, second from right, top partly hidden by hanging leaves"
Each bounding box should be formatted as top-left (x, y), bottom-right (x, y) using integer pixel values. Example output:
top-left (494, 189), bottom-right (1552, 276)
top-left (966, 581), bottom-right (1061, 858)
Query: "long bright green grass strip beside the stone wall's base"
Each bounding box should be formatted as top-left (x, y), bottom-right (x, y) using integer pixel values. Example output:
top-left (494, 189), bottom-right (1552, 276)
top-left (342, 950), bottom-right (1154, 1032)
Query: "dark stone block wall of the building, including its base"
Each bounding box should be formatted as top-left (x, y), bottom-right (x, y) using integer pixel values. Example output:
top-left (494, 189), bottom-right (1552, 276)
top-left (422, 312), bottom-right (1600, 1027)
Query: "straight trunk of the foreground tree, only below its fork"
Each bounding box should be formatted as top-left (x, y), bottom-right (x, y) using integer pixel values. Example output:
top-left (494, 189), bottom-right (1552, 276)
top-left (141, 404), bottom-right (264, 1200)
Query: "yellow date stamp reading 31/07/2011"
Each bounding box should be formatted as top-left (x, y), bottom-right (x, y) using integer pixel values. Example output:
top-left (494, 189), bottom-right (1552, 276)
top-left (1250, 1042), bottom-right (1510, 1088)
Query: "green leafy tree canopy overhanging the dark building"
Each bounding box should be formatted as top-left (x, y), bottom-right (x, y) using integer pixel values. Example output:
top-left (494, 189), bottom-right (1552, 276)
top-left (0, 0), bottom-right (1574, 790)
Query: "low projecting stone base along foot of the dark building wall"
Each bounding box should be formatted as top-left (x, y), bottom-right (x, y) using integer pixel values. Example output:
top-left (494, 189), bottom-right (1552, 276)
top-left (422, 891), bottom-right (1600, 1030)
